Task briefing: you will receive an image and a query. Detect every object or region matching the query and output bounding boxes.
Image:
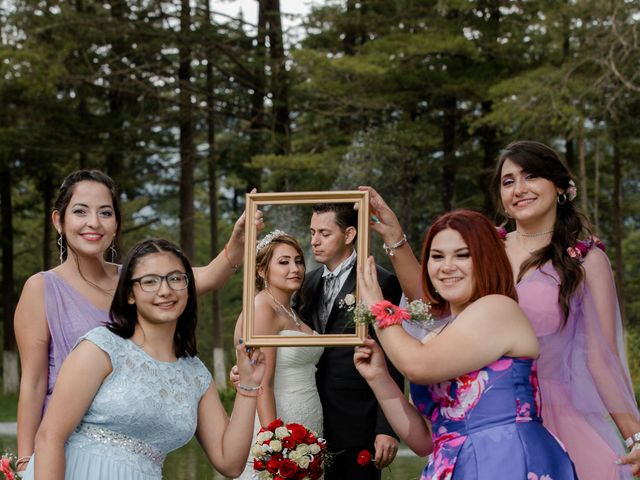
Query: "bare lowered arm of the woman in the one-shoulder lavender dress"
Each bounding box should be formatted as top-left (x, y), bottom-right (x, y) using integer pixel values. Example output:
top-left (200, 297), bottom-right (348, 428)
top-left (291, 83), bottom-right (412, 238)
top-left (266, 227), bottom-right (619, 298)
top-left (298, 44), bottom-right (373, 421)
top-left (13, 274), bottom-right (51, 470)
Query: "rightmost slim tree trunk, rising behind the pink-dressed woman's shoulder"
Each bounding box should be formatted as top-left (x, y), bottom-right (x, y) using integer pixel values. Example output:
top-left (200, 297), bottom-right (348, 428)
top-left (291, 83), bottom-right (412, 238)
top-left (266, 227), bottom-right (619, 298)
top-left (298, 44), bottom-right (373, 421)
top-left (611, 125), bottom-right (626, 321)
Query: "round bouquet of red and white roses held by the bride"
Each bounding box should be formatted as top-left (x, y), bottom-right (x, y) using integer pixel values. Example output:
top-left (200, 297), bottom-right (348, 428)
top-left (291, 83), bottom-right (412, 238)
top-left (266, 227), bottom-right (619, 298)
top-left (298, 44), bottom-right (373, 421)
top-left (251, 418), bottom-right (329, 480)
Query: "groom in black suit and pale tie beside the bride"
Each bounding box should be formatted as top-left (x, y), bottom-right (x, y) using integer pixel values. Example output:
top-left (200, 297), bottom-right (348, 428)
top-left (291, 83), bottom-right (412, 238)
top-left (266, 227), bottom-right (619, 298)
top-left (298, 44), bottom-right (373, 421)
top-left (301, 203), bottom-right (403, 480)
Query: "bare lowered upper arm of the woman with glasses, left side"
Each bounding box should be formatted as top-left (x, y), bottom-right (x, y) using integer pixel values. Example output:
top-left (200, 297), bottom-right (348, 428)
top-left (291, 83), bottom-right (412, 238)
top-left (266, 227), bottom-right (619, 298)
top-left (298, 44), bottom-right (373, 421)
top-left (35, 340), bottom-right (111, 480)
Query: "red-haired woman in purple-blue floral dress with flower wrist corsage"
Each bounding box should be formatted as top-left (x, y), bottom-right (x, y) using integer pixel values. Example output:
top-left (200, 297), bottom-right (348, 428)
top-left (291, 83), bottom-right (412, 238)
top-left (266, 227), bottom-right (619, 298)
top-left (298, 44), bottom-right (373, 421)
top-left (354, 210), bottom-right (577, 480)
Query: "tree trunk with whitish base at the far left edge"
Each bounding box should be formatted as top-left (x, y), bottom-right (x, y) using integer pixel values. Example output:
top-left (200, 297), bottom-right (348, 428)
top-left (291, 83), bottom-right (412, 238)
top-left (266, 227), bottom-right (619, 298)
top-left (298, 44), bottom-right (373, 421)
top-left (0, 161), bottom-right (20, 393)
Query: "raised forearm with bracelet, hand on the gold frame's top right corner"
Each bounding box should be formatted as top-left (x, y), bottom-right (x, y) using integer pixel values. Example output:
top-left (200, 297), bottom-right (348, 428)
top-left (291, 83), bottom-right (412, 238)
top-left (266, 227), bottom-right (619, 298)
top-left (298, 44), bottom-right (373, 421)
top-left (358, 186), bottom-right (423, 301)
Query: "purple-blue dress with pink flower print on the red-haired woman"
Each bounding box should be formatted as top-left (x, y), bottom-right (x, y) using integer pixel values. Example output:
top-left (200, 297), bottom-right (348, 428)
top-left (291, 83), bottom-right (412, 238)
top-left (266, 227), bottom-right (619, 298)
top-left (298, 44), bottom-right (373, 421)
top-left (411, 357), bottom-right (578, 480)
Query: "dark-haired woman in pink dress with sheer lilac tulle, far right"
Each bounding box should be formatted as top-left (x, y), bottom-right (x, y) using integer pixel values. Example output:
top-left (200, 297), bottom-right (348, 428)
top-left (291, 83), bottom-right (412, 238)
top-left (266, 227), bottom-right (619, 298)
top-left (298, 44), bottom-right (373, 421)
top-left (361, 141), bottom-right (640, 480)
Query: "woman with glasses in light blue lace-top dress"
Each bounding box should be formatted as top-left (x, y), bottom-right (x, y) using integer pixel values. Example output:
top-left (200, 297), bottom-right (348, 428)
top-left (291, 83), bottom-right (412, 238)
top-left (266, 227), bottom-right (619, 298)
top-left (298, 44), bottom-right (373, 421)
top-left (25, 240), bottom-right (264, 480)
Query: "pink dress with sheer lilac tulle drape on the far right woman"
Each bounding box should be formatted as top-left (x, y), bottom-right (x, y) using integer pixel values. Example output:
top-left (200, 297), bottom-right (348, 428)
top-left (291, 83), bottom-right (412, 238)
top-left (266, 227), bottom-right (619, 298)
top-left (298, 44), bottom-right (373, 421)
top-left (517, 247), bottom-right (638, 480)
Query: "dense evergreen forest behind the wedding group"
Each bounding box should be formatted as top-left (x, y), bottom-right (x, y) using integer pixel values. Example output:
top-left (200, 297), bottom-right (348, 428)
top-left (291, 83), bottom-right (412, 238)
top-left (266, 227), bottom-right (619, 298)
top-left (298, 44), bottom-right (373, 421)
top-left (0, 0), bottom-right (640, 404)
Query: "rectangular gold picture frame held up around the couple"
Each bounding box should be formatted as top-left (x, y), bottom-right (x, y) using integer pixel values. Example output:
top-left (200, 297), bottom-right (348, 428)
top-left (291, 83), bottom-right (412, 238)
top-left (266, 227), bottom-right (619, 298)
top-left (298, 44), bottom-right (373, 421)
top-left (242, 190), bottom-right (369, 347)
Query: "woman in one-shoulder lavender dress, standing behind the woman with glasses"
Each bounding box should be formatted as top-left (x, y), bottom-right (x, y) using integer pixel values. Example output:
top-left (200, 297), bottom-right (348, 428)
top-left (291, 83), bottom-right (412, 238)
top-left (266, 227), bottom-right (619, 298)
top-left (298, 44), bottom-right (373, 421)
top-left (14, 170), bottom-right (255, 470)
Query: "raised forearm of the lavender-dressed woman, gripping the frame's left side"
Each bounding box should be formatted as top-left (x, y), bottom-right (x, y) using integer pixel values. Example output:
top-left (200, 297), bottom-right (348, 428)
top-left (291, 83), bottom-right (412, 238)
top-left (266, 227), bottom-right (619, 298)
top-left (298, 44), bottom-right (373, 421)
top-left (193, 207), bottom-right (264, 295)
